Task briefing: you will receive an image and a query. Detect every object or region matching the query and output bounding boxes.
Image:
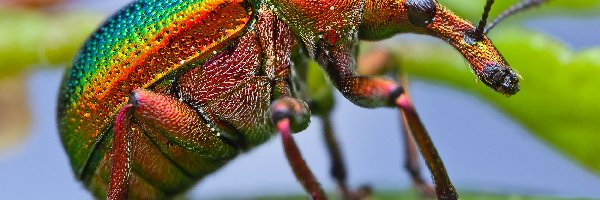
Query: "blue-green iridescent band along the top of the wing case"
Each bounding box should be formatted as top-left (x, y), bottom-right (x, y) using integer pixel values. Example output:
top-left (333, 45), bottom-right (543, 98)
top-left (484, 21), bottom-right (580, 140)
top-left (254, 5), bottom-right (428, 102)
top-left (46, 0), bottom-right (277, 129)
top-left (62, 0), bottom-right (204, 103)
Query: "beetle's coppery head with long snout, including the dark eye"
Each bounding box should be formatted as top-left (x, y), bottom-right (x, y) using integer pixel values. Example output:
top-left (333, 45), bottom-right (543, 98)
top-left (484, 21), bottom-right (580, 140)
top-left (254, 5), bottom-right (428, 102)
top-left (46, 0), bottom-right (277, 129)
top-left (404, 0), bottom-right (519, 95)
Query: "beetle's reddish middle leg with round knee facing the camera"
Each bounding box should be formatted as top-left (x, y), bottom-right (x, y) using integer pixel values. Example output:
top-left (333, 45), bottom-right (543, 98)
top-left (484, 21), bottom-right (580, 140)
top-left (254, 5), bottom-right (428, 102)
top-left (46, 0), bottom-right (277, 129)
top-left (271, 97), bottom-right (327, 199)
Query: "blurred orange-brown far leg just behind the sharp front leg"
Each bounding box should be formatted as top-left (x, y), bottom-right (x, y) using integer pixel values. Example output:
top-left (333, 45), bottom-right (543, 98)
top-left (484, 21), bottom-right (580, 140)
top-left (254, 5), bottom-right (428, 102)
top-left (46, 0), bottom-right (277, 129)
top-left (357, 47), bottom-right (435, 197)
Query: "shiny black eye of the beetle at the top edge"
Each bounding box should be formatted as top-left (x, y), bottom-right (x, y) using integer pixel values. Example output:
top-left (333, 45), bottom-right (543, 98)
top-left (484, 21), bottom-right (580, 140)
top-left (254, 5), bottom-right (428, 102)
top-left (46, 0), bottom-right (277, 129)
top-left (405, 0), bottom-right (436, 27)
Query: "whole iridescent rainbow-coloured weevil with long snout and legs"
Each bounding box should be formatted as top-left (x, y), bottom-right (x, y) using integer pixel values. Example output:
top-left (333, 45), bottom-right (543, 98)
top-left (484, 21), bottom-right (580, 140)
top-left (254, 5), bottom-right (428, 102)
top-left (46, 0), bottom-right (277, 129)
top-left (57, 0), bottom-right (541, 199)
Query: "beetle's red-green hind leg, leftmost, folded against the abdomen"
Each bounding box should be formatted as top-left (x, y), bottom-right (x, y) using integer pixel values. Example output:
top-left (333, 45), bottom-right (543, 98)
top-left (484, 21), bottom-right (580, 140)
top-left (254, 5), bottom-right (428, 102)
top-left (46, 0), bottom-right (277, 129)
top-left (108, 89), bottom-right (239, 199)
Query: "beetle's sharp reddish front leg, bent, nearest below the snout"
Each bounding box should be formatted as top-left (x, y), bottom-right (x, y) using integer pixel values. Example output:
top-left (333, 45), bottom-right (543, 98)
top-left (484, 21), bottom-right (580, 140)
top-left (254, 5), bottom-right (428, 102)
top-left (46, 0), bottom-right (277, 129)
top-left (316, 44), bottom-right (458, 199)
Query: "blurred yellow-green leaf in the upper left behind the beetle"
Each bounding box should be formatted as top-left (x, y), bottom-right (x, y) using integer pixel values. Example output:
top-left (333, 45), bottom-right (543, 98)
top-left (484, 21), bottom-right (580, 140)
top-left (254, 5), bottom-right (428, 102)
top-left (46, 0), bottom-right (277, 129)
top-left (0, 8), bottom-right (102, 78)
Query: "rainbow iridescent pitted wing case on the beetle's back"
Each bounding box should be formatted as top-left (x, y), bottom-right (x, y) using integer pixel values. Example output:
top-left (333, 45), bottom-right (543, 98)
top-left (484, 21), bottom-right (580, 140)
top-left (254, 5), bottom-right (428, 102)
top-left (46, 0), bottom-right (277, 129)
top-left (58, 0), bottom-right (252, 197)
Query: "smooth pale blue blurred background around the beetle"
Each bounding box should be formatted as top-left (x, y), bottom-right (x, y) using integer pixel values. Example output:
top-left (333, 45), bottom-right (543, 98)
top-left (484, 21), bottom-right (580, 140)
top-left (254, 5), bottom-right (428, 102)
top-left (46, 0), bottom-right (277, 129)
top-left (0, 0), bottom-right (600, 199)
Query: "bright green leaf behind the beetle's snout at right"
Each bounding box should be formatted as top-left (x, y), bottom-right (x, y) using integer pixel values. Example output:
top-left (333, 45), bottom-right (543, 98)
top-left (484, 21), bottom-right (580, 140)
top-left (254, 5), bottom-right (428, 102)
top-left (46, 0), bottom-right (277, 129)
top-left (380, 27), bottom-right (600, 173)
